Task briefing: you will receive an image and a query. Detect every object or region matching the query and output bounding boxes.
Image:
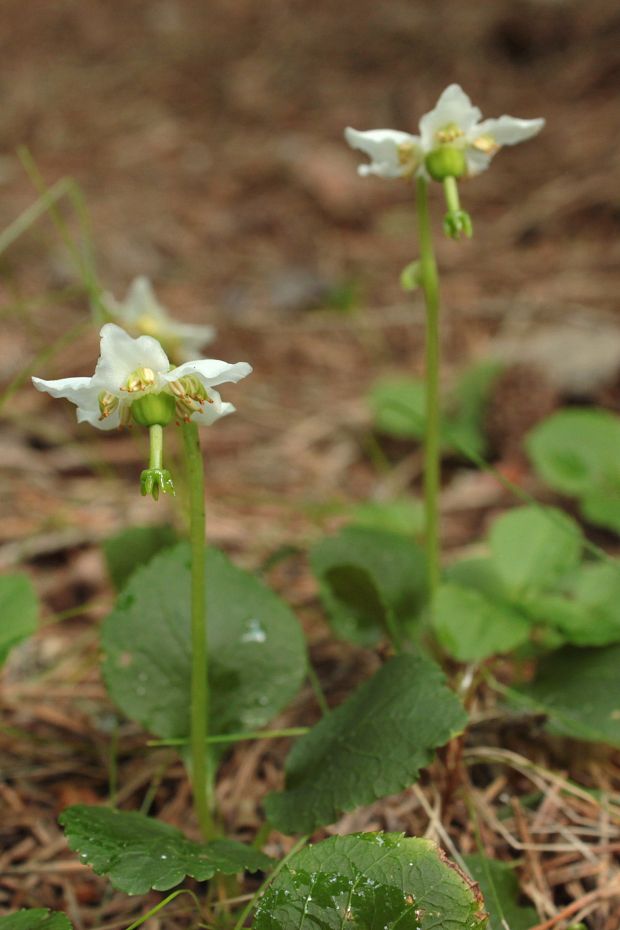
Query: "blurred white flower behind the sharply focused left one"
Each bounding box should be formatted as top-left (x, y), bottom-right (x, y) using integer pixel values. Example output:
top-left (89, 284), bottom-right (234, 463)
top-left (102, 276), bottom-right (215, 360)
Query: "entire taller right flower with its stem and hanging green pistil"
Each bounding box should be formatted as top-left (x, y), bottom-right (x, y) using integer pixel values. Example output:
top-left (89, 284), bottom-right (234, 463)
top-left (345, 84), bottom-right (545, 594)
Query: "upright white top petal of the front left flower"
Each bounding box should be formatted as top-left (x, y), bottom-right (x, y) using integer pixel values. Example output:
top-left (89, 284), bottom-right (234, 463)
top-left (93, 323), bottom-right (170, 395)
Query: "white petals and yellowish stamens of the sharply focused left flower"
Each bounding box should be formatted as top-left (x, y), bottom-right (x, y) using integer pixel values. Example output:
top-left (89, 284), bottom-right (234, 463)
top-left (32, 323), bottom-right (252, 430)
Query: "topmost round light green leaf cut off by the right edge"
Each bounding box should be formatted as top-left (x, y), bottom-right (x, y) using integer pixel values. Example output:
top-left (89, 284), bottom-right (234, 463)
top-left (526, 408), bottom-right (620, 497)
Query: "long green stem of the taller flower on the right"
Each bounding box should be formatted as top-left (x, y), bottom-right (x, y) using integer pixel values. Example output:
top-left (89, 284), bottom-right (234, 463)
top-left (416, 178), bottom-right (441, 597)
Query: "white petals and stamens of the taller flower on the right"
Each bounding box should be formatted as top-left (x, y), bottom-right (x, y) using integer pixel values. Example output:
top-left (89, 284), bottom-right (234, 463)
top-left (345, 84), bottom-right (545, 178)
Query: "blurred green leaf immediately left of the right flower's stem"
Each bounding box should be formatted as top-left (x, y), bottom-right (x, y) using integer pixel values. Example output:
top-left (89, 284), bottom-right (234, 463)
top-left (368, 378), bottom-right (426, 439)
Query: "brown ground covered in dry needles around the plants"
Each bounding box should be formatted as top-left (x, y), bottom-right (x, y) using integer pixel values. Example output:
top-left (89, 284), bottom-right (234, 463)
top-left (0, 0), bottom-right (620, 930)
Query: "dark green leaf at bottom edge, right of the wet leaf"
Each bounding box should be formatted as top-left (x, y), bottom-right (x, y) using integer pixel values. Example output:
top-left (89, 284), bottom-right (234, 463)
top-left (465, 855), bottom-right (538, 930)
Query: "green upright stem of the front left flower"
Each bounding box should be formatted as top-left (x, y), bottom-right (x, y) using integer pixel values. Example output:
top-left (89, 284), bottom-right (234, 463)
top-left (182, 423), bottom-right (215, 840)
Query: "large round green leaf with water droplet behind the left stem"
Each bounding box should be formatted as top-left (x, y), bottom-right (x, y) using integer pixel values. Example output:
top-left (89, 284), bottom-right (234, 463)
top-left (102, 544), bottom-right (306, 738)
